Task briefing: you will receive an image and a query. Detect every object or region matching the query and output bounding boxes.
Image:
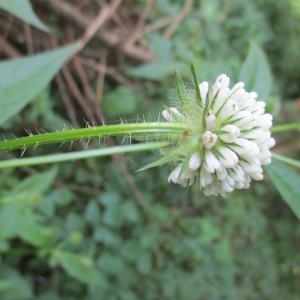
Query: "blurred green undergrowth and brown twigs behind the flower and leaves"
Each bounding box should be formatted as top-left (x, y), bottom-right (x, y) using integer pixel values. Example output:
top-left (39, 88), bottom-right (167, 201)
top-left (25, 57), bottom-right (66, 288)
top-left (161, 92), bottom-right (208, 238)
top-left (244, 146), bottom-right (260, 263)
top-left (0, 0), bottom-right (300, 300)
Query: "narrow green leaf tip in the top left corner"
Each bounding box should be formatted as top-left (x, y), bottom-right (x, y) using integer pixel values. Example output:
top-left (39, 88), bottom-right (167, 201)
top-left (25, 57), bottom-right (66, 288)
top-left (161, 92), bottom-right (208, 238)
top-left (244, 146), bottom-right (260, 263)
top-left (0, 0), bottom-right (49, 32)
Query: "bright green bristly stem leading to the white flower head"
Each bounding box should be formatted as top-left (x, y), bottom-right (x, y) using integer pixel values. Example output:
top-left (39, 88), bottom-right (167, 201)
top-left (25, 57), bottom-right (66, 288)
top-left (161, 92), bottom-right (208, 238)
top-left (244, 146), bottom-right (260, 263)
top-left (0, 122), bottom-right (187, 152)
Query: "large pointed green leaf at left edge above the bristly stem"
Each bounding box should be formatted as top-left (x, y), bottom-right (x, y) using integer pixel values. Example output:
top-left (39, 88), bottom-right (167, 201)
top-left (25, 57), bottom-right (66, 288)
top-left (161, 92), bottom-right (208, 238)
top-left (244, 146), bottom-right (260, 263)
top-left (0, 43), bottom-right (79, 125)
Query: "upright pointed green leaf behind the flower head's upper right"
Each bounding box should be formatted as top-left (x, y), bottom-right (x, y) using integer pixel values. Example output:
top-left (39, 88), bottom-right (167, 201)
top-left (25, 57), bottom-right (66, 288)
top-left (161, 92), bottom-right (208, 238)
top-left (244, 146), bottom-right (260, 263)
top-left (239, 42), bottom-right (273, 101)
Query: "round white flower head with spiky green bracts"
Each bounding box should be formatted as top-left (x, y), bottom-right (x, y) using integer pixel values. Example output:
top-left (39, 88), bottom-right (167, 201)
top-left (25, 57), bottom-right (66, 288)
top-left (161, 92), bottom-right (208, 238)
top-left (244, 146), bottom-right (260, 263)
top-left (162, 74), bottom-right (275, 197)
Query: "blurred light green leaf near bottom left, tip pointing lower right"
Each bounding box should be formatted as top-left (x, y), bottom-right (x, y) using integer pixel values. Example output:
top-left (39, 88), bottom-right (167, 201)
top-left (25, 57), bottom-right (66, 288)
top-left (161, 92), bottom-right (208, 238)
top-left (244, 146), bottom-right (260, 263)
top-left (52, 250), bottom-right (103, 285)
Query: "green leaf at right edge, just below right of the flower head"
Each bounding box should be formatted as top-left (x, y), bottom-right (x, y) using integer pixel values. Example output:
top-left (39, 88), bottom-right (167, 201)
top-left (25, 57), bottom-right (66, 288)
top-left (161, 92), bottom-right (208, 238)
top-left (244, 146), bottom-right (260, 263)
top-left (267, 160), bottom-right (300, 219)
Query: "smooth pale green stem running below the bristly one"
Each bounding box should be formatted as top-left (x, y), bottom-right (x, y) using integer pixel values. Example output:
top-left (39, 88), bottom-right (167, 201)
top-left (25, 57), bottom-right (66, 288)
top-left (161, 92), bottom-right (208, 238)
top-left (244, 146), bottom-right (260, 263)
top-left (0, 142), bottom-right (166, 169)
